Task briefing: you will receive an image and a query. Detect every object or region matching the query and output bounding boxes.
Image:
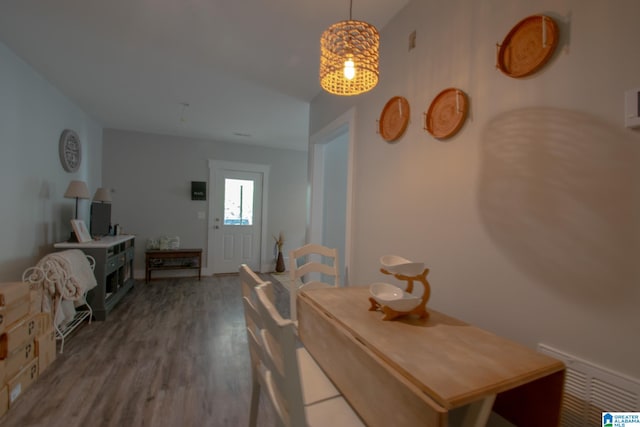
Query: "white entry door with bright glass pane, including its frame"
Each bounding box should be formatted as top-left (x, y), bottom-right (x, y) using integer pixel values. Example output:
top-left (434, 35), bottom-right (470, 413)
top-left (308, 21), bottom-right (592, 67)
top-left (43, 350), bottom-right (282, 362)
top-left (208, 162), bottom-right (264, 274)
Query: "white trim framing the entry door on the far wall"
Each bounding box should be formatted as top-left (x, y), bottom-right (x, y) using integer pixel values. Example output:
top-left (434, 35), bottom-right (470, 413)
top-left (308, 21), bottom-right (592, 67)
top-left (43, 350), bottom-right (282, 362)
top-left (207, 159), bottom-right (271, 274)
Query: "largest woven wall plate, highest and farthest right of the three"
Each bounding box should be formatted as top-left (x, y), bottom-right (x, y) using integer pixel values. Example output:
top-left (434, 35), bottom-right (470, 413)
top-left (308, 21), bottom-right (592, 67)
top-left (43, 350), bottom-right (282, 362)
top-left (496, 15), bottom-right (559, 78)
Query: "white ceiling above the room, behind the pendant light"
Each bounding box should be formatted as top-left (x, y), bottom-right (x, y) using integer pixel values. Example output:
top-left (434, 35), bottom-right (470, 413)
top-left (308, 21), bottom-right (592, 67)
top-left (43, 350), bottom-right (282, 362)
top-left (0, 0), bottom-right (409, 150)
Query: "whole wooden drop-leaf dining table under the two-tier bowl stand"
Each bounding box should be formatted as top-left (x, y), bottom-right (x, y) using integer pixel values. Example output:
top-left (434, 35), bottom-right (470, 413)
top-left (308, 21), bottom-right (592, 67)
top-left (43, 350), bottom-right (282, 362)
top-left (296, 286), bottom-right (565, 427)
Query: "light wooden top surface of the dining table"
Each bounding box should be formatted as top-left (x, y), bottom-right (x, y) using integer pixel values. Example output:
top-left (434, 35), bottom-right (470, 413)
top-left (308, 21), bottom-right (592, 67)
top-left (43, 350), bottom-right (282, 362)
top-left (299, 286), bottom-right (565, 409)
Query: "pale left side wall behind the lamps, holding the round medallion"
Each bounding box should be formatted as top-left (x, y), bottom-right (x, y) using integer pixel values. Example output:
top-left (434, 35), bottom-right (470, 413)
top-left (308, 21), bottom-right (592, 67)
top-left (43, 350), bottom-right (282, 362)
top-left (0, 43), bottom-right (102, 282)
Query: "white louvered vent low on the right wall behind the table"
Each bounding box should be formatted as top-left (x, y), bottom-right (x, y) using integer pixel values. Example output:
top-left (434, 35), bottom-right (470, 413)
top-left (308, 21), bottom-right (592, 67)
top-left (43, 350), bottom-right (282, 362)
top-left (538, 344), bottom-right (640, 427)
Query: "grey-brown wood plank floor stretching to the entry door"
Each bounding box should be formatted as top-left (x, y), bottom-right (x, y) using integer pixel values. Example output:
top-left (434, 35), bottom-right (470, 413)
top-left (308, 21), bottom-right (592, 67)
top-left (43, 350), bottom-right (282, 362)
top-left (0, 275), bottom-right (278, 427)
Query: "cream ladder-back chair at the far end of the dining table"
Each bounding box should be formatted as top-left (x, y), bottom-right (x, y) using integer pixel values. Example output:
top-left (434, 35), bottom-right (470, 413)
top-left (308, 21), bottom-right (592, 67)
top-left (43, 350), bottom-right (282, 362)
top-left (289, 243), bottom-right (340, 327)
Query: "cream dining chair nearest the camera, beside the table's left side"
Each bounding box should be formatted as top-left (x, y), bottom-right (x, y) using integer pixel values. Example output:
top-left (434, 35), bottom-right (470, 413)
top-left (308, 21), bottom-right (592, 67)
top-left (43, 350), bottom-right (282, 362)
top-left (255, 282), bottom-right (364, 427)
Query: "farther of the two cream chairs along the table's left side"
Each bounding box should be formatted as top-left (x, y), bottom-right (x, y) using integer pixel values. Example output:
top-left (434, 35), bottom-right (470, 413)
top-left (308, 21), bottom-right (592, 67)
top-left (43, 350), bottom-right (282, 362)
top-left (239, 264), bottom-right (361, 427)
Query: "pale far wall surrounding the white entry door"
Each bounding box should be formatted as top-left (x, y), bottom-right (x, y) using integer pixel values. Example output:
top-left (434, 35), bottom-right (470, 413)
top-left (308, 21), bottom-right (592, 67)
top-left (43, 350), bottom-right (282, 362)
top-left (102, 129), bottom-right (307, 277)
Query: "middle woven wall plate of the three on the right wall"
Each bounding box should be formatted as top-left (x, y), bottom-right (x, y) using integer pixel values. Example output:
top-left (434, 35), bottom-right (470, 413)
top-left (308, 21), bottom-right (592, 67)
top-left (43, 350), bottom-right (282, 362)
top-left (424, 87), bottom-right (469, 139)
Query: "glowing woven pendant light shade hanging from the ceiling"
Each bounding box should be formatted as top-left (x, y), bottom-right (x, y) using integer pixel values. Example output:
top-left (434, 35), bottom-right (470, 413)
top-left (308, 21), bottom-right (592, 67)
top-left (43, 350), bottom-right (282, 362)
top-left (320, 20), bottom-right (380, 95)
